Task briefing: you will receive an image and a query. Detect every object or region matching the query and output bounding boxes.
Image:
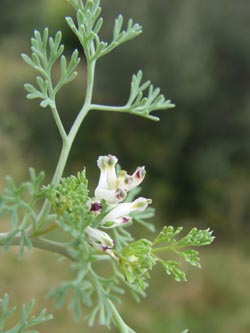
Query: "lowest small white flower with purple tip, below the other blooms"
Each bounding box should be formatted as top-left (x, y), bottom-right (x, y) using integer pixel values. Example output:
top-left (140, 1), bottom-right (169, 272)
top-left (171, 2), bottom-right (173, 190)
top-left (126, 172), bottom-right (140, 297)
top-left (85, 226), bottom-right (114, 251)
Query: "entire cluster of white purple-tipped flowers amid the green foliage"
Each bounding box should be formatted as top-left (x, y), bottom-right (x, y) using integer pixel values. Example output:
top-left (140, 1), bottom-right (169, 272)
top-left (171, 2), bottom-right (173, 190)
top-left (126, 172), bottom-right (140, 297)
top-left (85, 155), bottom-right (151, 252)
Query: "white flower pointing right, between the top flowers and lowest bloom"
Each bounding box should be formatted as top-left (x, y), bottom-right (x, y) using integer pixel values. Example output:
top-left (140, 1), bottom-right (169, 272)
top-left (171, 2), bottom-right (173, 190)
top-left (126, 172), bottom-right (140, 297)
top-left (101, 197), bottom-right (152, 228)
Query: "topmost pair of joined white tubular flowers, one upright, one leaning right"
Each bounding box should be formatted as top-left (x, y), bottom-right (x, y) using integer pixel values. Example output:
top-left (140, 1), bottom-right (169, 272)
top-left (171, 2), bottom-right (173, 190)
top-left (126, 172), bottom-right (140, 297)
top-left (95, 155), bottom-right (146, 205)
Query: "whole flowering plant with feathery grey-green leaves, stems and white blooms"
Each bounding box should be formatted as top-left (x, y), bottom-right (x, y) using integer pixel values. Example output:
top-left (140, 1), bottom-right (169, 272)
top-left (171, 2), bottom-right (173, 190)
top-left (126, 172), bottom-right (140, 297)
top-left (0, 0), bottom-right (213, 333)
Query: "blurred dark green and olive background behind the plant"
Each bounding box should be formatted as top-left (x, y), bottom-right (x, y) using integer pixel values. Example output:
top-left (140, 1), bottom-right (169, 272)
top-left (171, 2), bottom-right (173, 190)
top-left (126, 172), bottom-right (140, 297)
top-left (0, 0), bottom-right (250, 333)
